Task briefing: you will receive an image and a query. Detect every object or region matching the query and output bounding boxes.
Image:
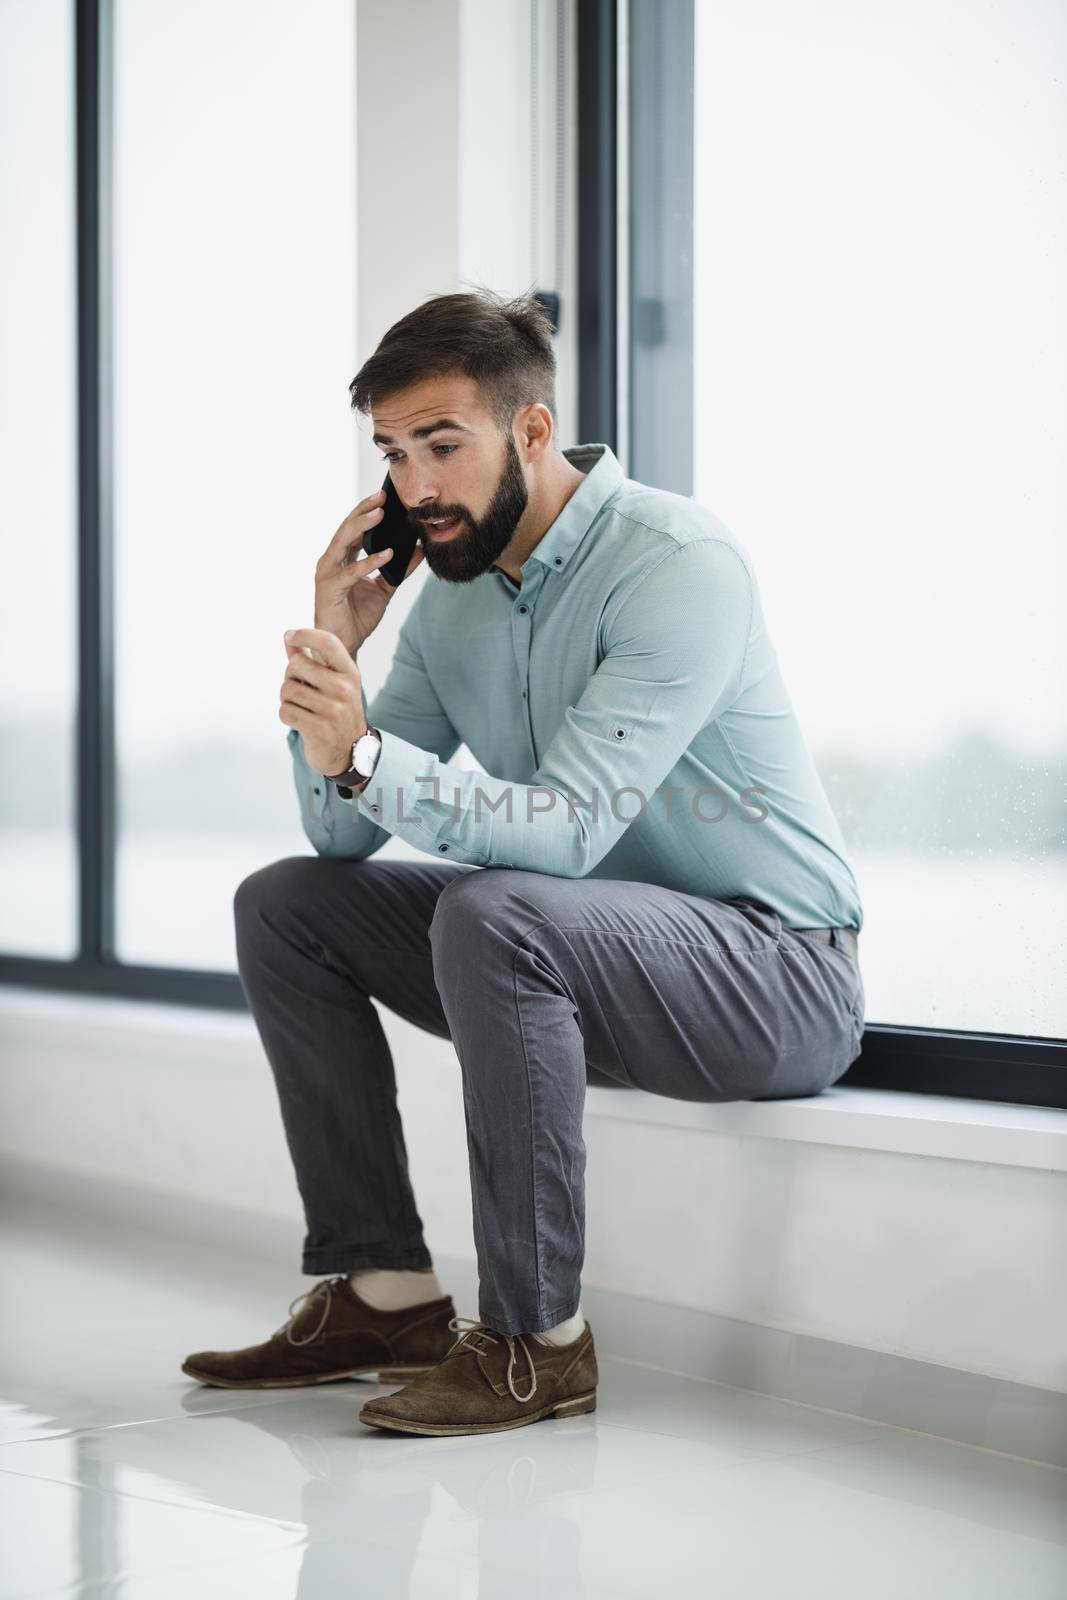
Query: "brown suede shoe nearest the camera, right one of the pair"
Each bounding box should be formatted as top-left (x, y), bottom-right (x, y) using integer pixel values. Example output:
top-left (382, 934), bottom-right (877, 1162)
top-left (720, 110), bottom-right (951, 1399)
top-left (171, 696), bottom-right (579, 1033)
top-left (360, 1317), bottom-right (597, 1434)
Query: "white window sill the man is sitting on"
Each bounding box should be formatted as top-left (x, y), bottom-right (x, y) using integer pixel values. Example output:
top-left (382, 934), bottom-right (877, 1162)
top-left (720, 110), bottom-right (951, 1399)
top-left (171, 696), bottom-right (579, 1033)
top-left (0, 986), bottom-right (1067, 1171)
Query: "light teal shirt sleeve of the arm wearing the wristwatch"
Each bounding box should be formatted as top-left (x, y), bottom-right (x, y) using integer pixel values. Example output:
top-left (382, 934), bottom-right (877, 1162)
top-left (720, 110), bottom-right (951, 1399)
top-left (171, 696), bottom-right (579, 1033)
top-left (350, 539), bottom-right (753, 878)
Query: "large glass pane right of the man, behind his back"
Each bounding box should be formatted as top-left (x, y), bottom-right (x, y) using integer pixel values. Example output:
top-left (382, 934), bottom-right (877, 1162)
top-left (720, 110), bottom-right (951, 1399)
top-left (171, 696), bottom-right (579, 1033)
top-left (696, 0), bottom-right (1067, 1037)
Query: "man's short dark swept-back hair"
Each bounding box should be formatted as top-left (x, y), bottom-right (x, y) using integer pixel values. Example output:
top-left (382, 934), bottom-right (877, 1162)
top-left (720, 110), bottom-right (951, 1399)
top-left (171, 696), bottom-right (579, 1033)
top-left (349, 288), bottom-right (558, 430)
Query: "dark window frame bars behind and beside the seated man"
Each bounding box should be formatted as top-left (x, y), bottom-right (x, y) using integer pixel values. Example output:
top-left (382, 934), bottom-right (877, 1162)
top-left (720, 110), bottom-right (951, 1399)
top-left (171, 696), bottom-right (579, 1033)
top-left (0, 0), bottom-right (1067, 1107)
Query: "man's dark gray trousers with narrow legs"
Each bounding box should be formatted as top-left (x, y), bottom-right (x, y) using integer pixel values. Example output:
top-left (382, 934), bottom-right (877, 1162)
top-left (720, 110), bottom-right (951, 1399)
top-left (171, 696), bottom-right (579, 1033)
top-left (234, 856), bottom-right (864, 1333)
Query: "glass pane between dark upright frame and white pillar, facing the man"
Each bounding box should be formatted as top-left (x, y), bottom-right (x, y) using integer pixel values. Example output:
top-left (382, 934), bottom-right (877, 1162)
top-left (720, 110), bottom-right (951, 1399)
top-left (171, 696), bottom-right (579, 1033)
top-left (115, 0), bottom-right (360, 970)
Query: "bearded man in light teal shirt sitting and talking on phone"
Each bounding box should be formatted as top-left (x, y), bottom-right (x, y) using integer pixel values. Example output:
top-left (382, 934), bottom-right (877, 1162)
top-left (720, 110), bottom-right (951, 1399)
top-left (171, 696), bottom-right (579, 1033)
top-left (184, 293), bottom-right (864, 1434)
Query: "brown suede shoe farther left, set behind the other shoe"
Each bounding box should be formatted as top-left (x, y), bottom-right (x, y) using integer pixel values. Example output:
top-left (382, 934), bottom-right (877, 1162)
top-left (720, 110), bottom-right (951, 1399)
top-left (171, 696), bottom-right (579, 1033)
top-left (181, 1277), bottom-right (456, 1389)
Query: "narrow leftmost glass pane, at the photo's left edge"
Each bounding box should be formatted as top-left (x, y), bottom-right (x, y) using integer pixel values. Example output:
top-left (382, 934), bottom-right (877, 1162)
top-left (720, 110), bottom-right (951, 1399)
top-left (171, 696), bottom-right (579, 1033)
top-left (0, 0), bottom-right (78, 958)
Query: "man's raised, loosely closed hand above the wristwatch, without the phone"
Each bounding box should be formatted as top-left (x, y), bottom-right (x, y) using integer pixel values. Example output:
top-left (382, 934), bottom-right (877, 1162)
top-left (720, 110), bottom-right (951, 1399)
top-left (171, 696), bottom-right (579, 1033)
top-left (278, 627), bottom-right (366, 776)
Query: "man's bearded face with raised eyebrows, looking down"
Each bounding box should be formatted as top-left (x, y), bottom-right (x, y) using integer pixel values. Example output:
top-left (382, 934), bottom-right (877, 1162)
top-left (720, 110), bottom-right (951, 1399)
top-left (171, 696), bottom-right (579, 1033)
top-left (373, 374), bottom-right (530, 584)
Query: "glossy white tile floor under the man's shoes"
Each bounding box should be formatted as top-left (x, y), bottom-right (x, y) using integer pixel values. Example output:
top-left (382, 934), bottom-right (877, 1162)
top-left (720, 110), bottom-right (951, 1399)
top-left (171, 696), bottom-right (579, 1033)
top-left (0, 1205), bottom-right (1067, 1600)
